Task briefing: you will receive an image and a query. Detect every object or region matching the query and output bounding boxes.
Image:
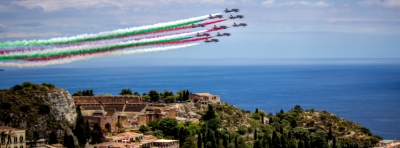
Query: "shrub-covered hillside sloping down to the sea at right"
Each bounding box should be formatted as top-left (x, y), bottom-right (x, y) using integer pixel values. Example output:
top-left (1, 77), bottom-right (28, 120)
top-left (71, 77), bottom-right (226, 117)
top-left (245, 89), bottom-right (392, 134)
top-left (214, 102), bottom-right (381, 147)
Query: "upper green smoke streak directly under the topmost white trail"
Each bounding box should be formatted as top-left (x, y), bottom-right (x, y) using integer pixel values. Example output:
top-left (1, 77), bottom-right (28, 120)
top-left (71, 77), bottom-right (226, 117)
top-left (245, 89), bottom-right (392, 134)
top-left (0, 19), bottom-right (204, 48)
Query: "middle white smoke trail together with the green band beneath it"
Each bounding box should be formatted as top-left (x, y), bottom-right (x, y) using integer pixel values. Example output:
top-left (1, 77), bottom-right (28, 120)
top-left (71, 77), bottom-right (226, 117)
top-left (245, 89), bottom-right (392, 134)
top-left (0, 30), bottom-right (206, 60)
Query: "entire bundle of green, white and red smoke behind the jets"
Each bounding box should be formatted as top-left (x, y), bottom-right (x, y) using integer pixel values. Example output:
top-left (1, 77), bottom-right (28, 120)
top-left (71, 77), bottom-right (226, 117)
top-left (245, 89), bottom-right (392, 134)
top-left (0, 11), bottom-right (241, 67)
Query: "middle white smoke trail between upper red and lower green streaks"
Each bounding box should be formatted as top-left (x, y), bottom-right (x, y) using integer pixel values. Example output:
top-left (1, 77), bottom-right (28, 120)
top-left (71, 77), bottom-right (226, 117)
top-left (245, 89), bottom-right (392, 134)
top-left (0, 30), bottom-right (207, 57)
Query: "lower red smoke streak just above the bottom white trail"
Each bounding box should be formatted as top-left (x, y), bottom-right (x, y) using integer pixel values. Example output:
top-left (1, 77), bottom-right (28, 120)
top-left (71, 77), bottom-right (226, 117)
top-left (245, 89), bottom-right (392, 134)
top-left (25, 37), bottom-right (212, 62)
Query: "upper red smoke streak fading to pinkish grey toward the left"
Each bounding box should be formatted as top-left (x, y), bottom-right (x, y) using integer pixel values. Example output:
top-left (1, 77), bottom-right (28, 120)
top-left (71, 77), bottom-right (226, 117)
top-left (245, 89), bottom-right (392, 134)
top-left (0, 19), bottom-right (228, 55)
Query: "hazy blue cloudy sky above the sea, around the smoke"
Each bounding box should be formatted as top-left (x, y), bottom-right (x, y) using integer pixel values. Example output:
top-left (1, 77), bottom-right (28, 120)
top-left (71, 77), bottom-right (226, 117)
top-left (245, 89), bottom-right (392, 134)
top-left (0, 0), bottom-right (400, 65)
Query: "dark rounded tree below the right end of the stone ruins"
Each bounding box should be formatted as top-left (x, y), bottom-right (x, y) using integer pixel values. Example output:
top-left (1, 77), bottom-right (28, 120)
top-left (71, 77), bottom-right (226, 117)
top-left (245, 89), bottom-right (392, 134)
top-left (159, 117), bottom-right (179, 137)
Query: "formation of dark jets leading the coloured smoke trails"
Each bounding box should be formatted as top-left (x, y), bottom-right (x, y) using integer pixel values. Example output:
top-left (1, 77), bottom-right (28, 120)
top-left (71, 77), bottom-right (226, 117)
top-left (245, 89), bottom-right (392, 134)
top-left (205, 8), bottom-right (247, 43)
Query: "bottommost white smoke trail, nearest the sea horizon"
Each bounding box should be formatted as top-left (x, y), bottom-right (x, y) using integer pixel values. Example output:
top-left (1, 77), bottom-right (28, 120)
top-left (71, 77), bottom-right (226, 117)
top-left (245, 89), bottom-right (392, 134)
top-left (0, 43), bottom-right (199, 67)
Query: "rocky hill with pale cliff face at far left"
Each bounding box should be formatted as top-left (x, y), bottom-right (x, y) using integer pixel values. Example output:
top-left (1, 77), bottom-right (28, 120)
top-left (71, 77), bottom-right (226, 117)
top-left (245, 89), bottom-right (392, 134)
top-left (0, 82), bottom-right (76, 145)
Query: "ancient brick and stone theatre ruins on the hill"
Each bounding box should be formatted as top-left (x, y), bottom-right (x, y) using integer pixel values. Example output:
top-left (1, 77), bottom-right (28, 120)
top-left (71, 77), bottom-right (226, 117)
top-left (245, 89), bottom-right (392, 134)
top-left (73, 96), bottom-right (176, 132)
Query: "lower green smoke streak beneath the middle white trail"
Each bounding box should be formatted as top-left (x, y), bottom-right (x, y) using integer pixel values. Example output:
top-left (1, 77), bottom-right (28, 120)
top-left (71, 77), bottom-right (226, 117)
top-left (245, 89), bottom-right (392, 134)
top-left (0, 37), bottom-right (191, 60)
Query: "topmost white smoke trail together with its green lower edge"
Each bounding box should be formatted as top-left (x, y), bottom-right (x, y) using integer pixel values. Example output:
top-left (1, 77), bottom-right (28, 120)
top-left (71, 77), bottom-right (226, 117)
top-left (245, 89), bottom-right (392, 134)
top-left (0, 14), bottom-right (222, 48)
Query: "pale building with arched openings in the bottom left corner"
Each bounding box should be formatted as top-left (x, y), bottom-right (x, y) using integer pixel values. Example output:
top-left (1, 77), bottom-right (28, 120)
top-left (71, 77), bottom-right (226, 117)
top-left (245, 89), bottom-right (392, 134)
top-left (0, 126), bottom-right (26, 148)
